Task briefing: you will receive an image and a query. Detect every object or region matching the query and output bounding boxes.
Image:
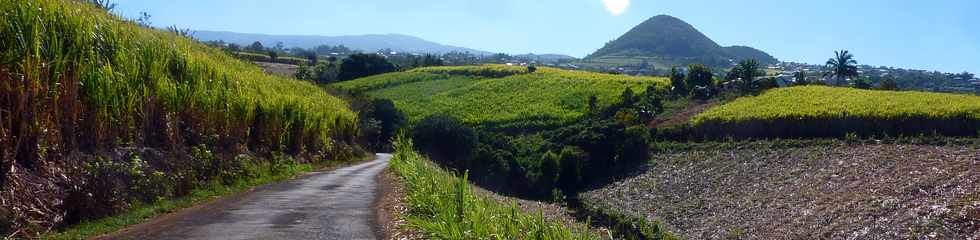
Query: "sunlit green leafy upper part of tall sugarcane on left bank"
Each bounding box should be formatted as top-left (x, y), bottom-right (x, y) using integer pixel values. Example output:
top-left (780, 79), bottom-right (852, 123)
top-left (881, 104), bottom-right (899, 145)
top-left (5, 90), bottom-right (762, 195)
top-left (0, 0), bottom-right (355, 146)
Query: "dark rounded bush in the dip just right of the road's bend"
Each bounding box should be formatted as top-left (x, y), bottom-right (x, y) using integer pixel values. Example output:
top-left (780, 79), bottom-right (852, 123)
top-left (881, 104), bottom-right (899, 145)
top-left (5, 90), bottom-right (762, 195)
top-left (412, 114), bottom-right (477, 169)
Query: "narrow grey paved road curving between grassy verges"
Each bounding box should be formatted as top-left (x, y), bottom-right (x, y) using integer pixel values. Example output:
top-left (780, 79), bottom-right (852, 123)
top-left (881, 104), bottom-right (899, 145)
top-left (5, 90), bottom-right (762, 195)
top-left (107, 154), bottom-right (391, 239)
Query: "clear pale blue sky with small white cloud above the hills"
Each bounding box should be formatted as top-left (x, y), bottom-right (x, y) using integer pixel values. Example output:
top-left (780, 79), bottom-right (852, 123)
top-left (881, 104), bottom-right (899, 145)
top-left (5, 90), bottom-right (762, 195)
top-left (115, 0), bottom-right (980, 73)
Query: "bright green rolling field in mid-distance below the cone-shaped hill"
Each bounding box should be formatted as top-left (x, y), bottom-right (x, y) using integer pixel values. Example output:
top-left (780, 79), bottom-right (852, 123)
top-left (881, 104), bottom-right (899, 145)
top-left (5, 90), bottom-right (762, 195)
top-left (333, 65), bottom-right (669, 125)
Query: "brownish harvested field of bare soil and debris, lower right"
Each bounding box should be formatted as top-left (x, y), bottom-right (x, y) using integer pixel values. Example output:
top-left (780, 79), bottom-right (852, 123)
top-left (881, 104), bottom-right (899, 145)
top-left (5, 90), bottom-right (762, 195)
top-left (584, 142), bottom-right (980, 239)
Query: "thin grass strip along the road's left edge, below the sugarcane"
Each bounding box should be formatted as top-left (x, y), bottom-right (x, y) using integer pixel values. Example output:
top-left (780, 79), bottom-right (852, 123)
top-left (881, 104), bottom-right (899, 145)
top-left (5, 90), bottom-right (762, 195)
top-left (39, 155), bottom-right (373, 240)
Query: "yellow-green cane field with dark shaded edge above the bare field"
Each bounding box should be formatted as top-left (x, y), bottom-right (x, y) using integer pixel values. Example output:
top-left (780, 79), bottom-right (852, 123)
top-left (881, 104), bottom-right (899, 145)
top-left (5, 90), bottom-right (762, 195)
top-left (692, 86), bottom-right (980, 138)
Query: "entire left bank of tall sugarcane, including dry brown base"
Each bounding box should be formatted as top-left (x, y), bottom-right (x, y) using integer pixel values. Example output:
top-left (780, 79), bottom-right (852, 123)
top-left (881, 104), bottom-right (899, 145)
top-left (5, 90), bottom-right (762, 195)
top-left (0, 0), bottom-right (358, 236)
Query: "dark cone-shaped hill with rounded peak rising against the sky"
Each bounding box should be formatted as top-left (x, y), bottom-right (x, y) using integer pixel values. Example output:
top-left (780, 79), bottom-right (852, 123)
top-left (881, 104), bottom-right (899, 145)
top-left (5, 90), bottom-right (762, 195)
top-left (586, 15), bottom-right (778, 67)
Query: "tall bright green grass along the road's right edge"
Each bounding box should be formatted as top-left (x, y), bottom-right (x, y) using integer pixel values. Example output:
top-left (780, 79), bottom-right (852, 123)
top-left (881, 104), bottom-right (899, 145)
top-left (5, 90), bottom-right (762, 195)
top-left (390, 137), bottom-right (600, 239)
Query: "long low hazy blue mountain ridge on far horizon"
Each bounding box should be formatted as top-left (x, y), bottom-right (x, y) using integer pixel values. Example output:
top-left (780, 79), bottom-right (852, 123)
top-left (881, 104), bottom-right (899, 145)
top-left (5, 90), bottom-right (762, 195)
top-left (194, 31), bottom-right (491, 55)
